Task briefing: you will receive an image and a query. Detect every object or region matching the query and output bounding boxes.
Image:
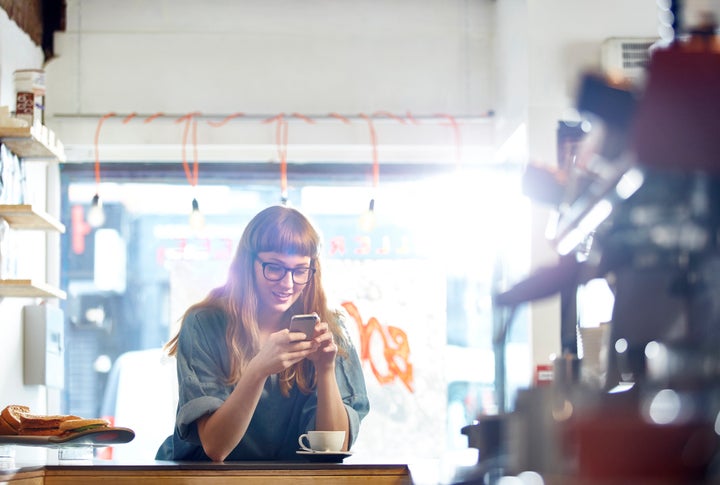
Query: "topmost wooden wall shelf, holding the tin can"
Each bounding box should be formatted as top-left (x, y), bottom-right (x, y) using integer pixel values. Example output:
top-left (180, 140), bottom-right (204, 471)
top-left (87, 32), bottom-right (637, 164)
top-left (0, 126), bottom-right (65, 162)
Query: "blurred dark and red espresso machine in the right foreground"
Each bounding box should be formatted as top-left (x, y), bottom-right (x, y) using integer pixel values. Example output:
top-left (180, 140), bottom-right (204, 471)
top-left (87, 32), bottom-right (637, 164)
top-left (458, 7), bottom-right (720, 483)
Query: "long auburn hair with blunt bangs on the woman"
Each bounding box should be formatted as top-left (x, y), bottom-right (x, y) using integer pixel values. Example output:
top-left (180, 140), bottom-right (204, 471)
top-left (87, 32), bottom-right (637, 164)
top-left (165, 205), bottom-right (348, 396)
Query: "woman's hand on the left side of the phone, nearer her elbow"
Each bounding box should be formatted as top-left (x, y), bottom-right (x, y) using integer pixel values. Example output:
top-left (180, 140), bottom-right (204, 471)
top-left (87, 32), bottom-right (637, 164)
top-left (248, 329), bottom-right (318, 376)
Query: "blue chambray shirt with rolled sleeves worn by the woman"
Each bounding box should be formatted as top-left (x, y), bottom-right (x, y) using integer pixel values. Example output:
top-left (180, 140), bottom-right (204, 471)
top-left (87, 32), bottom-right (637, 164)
top-left (155, 309), bottom-right (369, 461)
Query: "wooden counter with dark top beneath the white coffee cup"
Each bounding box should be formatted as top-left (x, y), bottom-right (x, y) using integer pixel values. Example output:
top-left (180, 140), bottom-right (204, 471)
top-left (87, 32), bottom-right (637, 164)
top-left (0, 461), bottom-right (412, 485)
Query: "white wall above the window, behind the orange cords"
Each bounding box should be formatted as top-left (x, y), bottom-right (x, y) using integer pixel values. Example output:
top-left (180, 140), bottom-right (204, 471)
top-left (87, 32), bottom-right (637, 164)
top-left (48, 0), bottom-right (495, 163)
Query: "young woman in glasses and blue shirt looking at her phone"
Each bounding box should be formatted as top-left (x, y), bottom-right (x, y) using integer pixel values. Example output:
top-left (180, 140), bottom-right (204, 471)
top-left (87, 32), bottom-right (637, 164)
top-left (156, 206), bottom-right (369, 462)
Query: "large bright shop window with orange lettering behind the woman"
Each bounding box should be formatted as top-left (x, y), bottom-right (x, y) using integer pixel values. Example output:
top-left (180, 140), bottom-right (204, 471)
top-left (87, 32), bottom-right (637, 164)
top-left (57, 164), bottom-right (529, 460)
